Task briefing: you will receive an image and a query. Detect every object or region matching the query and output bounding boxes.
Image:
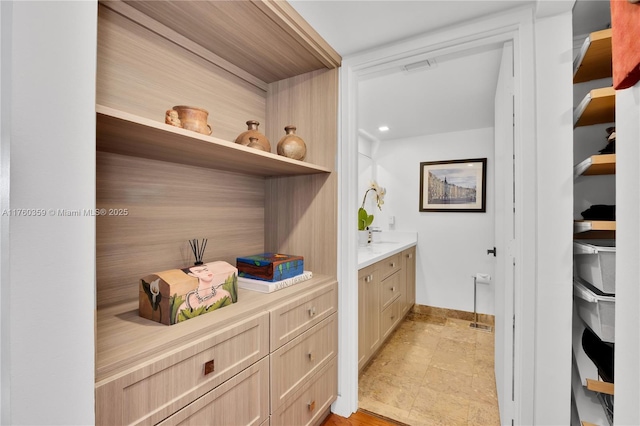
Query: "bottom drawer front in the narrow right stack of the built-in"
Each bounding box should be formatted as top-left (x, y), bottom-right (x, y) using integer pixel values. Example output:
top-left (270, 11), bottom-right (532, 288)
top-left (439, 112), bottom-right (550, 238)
top-left (271, 357), bottom-right (338, 426)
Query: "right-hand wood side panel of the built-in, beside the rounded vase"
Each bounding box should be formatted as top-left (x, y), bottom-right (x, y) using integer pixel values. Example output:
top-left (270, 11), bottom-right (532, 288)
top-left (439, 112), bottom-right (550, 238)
top-left (265, 69), bottom-right (338, 276)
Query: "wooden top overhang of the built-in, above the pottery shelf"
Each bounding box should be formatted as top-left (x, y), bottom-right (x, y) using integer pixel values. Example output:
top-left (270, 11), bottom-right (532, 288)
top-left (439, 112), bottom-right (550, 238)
top-left (100, 0), bottom-right (342, 87)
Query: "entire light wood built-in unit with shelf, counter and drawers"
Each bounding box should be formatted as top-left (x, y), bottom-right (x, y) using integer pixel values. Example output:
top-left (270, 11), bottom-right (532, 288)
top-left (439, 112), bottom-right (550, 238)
top-left (96, 0), bottom-right (341, 425)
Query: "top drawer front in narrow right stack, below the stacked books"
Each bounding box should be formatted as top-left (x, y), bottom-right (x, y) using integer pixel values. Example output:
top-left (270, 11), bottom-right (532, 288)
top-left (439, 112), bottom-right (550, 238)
top-left (271, 282), bottom-right (338, 352)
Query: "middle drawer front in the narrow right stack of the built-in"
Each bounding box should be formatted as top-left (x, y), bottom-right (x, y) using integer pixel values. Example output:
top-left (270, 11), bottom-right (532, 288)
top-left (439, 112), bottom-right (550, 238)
top-left (269, 314), bottom-right (338, 413)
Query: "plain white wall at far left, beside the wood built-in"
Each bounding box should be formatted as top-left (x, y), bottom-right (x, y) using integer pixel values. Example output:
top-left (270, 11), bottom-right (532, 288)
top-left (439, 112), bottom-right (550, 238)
top-left (0, 1), bottom-right (97, 425)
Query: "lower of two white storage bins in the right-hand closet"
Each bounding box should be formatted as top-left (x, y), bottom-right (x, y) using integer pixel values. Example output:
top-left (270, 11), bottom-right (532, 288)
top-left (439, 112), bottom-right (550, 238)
top-left (573, 279), bottom-right (616, 343)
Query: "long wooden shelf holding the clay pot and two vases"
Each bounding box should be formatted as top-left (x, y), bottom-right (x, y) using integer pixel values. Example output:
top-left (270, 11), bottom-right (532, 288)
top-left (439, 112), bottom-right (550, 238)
top-left (96, 105), bottom-right (331, 177)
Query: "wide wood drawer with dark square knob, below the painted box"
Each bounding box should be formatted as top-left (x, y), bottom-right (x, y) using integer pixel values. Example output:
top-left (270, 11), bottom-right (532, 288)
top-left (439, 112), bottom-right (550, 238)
top-left (96, 312), bottom-right (269, 425)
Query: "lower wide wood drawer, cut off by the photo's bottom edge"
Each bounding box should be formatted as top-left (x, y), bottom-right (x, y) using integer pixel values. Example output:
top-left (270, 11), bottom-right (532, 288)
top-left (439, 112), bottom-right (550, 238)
top-left (159, 358), bottom-right (269, 426)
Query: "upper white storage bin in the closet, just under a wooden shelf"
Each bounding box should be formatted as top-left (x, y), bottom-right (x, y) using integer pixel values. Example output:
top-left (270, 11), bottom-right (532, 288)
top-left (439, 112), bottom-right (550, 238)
top-left (573, 240), bottom-right (616, 294)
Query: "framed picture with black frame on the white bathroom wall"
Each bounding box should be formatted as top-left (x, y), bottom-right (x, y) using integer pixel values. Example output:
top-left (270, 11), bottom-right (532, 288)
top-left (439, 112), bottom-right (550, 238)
top-left (420, 158), bottom-right (487, 213)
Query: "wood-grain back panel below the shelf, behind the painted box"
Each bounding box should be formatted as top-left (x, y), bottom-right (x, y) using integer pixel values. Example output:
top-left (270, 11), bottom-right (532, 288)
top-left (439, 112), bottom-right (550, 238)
top-left (96, 152), bottom-right (264, 308)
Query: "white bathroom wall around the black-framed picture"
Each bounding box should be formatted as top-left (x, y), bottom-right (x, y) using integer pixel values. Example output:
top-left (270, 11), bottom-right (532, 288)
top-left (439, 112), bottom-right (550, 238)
top-left (374, 128), bottom-right (494, 314)
